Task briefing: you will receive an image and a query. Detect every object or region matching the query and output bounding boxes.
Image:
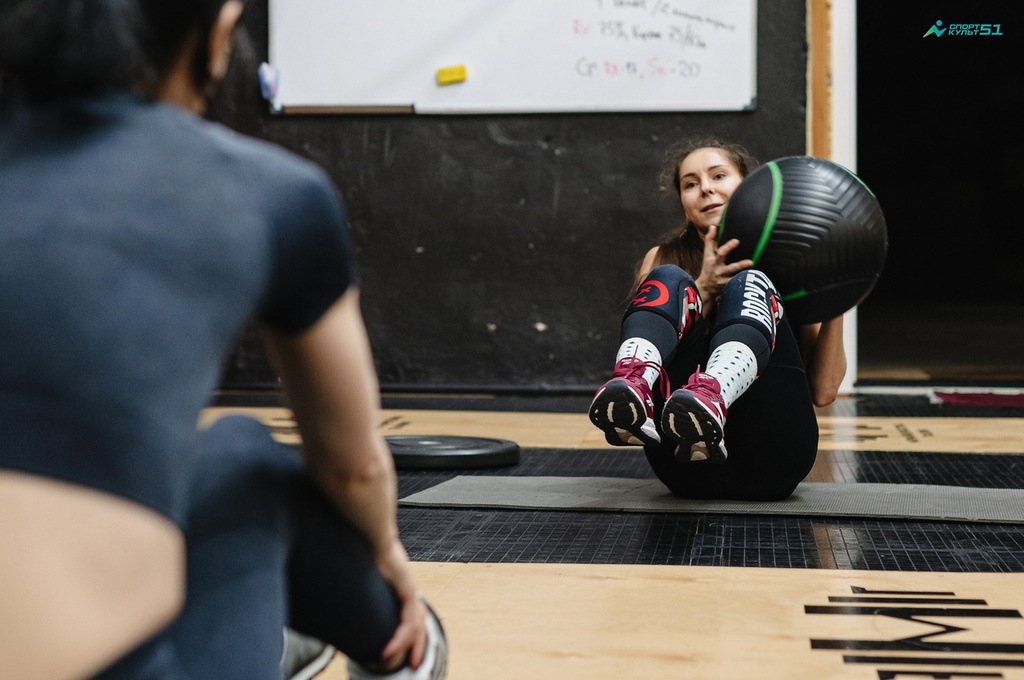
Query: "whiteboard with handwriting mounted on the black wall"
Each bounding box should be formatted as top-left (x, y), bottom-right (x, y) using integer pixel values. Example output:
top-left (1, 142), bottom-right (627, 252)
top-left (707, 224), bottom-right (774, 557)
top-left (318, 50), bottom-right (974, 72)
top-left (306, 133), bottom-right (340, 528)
top-left (268, 0), bottom-right (757, 114)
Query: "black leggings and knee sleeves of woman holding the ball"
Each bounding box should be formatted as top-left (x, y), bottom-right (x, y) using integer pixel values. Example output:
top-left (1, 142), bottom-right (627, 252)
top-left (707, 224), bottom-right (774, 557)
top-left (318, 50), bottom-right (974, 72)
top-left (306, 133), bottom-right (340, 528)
top-left (622, 265), bottom-right (818, 501)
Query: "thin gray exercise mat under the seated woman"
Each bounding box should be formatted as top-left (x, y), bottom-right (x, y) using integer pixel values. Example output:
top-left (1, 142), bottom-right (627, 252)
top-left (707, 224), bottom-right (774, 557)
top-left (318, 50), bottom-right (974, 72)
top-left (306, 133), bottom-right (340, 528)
top-left (399, 476), bottom-right (1024, 524)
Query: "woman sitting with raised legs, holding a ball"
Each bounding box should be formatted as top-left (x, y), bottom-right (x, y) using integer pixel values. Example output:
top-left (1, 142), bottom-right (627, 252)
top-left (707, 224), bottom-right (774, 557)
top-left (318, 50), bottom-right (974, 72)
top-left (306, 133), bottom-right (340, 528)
top-left (590, 138), bottom-right (847, 500)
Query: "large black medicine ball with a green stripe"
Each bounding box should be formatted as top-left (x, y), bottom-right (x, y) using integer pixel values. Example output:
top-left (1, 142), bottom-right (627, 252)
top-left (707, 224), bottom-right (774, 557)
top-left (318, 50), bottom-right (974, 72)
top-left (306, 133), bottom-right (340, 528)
top-left (718, 156), bottom-right (889, 324)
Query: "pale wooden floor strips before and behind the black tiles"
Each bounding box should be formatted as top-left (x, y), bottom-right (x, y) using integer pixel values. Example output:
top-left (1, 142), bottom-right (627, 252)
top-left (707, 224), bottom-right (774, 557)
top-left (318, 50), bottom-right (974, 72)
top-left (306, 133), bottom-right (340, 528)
top-left (205, 387), bottom-right (1024, 680)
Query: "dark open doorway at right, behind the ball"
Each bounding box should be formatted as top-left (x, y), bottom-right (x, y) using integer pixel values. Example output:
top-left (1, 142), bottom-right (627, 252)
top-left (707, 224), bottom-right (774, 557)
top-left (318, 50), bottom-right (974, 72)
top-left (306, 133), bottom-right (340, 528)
top-left (857, 0), bottom-right (1024, 382)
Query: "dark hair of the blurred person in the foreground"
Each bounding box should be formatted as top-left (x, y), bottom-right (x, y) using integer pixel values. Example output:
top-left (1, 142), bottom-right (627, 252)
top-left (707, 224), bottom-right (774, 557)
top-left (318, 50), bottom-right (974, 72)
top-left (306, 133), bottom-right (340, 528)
top-left (0, 0), bottom-right (235, 101)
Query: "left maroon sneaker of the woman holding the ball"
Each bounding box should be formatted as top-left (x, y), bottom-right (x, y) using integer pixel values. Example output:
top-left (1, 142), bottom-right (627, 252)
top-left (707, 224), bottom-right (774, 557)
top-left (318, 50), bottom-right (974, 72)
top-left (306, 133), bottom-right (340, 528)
top-left (590, 356), bottom-right (668, 447)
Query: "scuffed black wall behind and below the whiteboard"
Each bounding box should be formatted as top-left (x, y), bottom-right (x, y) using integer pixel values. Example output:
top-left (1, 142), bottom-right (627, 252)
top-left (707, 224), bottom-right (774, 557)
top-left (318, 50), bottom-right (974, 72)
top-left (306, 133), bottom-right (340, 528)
top-left (216, 0), bottom-right (807, 391)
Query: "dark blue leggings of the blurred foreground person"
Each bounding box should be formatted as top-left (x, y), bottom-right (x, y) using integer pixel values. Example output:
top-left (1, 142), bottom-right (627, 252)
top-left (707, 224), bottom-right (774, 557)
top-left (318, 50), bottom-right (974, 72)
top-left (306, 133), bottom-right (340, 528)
top-left (98, 416), bottom-right (399, 680)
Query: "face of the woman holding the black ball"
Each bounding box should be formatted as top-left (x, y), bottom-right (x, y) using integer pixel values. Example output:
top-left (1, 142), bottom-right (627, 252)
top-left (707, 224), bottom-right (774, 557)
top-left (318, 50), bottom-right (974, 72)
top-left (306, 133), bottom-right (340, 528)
top-left (679, 148), bottom-right (742, 236)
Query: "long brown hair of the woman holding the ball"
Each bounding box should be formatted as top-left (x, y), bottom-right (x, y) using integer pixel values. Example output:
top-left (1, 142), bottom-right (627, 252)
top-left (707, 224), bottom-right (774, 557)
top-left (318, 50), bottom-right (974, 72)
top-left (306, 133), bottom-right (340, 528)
top-left (633, 135), bottom-right (758, 291)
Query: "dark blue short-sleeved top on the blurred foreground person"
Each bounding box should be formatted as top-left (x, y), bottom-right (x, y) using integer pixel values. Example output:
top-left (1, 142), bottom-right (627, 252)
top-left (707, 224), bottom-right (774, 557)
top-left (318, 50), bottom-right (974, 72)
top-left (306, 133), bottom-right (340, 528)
top-left (0, 93), bottom-right (354, 522)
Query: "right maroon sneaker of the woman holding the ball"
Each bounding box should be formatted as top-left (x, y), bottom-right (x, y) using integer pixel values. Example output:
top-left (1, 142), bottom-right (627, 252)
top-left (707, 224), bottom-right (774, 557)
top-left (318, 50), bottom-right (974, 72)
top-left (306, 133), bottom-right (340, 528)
top-left (662, 371), bottom-right (728, 463)
